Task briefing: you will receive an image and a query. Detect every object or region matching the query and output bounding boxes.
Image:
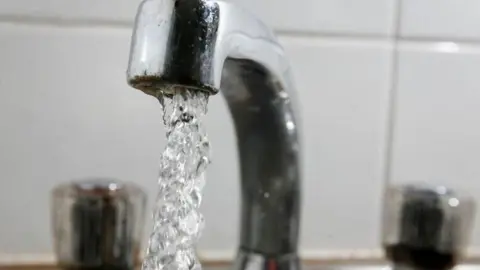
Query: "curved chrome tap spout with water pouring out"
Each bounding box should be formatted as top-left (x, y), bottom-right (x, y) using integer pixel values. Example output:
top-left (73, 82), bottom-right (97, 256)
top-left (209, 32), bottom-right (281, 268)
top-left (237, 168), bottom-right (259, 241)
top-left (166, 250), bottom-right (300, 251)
top-left (127, 0), bottom-right (300, 269)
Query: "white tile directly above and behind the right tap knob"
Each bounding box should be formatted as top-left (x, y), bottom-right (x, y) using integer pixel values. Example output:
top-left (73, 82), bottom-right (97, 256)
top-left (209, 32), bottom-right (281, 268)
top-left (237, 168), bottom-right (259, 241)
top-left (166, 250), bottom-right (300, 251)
top-left (392, 44), bottom-right (480, 245)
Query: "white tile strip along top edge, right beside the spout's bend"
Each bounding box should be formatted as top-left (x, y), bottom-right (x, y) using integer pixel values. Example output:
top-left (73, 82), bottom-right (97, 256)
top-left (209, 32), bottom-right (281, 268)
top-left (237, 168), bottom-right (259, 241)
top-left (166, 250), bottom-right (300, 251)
top-left (235, 0), bottom-right (395, 35)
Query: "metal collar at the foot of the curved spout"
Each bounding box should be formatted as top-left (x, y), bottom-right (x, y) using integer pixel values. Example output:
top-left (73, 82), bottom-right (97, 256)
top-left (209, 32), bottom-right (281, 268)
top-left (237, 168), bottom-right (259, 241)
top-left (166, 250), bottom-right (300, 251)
top-left (233, 251), bottom-right (301, 270)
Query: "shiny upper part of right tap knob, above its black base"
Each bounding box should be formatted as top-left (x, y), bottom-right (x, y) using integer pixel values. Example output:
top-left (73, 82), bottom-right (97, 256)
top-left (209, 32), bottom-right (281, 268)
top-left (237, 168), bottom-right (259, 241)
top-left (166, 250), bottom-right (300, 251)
top-left (383, 184), bottom-right (475, 254)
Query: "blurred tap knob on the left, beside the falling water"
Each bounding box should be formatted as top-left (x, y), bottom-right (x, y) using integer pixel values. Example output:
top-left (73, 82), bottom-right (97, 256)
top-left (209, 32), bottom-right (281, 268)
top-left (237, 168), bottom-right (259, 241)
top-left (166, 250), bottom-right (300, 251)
top-left (51, 179), bottom-right (146, 270)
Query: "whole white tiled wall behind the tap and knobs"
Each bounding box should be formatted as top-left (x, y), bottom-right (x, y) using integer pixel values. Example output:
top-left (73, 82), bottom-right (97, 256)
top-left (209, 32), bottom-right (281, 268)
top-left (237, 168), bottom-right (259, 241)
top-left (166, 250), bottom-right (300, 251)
top-left (0, 0), bottom-right (480, 258)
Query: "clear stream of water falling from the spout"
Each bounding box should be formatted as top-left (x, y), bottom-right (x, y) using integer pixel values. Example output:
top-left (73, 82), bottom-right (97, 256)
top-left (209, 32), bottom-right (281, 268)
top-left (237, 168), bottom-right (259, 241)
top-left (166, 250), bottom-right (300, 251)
top-left (142, 88), bottom-right (210, 270)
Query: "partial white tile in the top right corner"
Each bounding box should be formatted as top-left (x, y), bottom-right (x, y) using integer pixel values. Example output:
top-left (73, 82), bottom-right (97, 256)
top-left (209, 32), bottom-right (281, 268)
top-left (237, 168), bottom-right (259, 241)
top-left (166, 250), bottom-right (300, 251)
top-left (401, 0), bottom-right (480, 40)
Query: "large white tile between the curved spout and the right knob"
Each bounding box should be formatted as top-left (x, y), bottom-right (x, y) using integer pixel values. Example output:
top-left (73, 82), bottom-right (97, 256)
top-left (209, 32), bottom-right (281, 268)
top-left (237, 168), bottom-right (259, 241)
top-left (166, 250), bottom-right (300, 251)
top-left (284, 39), bottom-right (391, 250)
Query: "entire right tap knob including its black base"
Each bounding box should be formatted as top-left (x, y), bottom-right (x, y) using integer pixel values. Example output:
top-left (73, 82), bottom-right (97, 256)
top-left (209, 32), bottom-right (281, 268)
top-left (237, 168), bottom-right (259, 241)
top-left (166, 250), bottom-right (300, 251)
top-left (382, 184), bottom-right (475, 270)
